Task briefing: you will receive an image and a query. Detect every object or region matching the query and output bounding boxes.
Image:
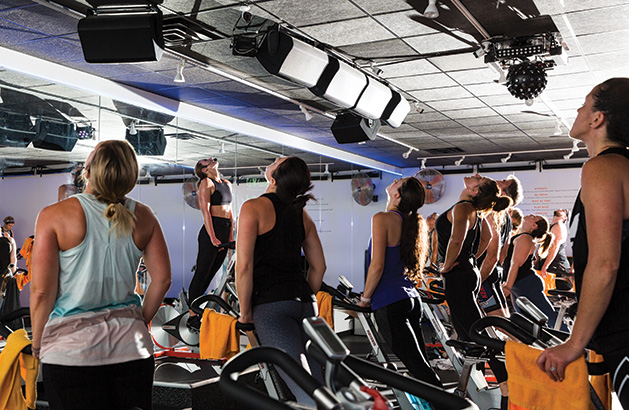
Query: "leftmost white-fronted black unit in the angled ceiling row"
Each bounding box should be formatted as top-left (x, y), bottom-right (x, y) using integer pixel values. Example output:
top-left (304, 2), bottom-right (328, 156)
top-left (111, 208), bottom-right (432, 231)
top-left (256, 30), bottom-right (328, 88)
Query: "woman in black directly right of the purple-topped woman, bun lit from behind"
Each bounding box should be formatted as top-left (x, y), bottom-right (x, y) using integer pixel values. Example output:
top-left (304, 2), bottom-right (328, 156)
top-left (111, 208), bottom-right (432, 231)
top-left (435, 174), bottom-right (511, 408)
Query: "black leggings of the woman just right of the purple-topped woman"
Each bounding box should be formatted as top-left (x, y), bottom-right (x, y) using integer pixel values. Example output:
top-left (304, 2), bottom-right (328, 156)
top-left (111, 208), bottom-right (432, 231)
top-left (444, 262), bottom-right (507, 383)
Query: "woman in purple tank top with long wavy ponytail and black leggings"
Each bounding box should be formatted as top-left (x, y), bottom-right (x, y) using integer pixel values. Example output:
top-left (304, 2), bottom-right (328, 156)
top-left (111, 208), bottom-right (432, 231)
top-left (359, 178), bottom-right (442, 387)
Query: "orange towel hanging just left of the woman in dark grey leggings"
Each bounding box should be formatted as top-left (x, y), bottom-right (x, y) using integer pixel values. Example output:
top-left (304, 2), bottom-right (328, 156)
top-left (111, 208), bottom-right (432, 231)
top-left (199, 309), bottom-right (240, 360)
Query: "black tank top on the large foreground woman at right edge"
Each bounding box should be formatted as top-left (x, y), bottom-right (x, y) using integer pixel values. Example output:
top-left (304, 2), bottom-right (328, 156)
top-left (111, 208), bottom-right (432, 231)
top-left (570, 148), bottom-right (629, 354)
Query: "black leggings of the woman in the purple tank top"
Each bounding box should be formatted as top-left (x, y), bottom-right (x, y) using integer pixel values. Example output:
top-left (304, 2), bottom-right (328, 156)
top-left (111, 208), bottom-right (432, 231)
top-left (375, 298), bottom-right (443, 387)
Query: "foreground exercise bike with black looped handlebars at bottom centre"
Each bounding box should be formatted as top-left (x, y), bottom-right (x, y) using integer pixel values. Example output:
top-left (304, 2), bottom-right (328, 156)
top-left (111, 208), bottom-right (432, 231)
top-left (219, 317), bottom-right (478, 410)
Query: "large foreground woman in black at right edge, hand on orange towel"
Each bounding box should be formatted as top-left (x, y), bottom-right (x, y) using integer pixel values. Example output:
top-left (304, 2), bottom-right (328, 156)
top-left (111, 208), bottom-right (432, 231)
top-left (537, 78), bottom-right (629, 409)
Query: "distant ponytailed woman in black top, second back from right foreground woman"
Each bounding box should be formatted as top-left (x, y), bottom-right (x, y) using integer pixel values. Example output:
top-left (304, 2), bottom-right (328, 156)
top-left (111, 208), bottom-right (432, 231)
top-left (502, 214), bottom-right (568, 331)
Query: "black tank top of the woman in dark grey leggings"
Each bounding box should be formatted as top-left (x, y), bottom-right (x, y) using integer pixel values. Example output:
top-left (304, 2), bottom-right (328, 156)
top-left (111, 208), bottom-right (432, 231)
top-left (252, 193), bottom-right (313, 306)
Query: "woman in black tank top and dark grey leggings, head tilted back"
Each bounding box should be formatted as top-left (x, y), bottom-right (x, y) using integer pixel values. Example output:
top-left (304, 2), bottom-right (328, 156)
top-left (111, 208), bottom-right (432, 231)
top-left (236, 157), bottom-right (326, 405)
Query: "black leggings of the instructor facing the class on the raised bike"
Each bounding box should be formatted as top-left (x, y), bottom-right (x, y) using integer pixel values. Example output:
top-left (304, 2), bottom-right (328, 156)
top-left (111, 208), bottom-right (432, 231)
top-left (188, 216), bottom-right (232, 303)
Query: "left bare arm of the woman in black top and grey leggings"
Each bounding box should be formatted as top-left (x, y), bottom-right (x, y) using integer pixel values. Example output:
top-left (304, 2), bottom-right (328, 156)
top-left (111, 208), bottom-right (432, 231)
top-left (236, 198), bottom-right (260, 323)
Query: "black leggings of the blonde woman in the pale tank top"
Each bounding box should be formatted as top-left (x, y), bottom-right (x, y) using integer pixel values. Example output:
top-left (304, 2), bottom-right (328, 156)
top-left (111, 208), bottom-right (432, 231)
top-left (42, 356), bottom-right (155, 410)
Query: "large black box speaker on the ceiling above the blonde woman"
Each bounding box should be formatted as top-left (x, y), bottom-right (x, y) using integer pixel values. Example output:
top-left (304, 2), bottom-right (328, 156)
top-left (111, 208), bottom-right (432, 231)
top-left (78, 6), bottom-right (164, 63)
